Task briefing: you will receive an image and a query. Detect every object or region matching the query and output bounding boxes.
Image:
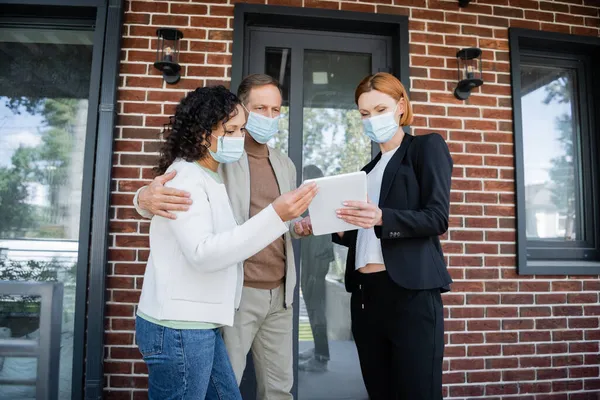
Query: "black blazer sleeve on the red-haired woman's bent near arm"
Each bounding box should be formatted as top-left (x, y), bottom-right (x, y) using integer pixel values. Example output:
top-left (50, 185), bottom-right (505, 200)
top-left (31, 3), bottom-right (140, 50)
top-left (375, 133), bottom-right (453, 239)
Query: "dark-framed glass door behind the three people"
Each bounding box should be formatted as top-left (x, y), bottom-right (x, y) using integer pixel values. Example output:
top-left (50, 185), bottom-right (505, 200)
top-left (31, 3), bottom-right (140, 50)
top-left (245, 28), bottom-right (391, 400)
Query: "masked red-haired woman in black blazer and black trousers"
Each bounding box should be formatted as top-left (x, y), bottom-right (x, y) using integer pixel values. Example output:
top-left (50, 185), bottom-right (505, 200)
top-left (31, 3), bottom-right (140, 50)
top-left (333, 73), bottom-right (452, 400)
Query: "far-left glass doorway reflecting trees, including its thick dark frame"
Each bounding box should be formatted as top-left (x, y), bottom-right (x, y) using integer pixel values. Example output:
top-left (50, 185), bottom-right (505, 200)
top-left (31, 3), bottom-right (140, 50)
top-left (0, 0), bottom-right (122, 400)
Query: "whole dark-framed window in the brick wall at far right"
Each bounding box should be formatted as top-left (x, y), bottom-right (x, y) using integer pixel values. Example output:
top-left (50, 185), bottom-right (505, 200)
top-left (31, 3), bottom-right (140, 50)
top-left (510, 29), bottom-right (600, 275)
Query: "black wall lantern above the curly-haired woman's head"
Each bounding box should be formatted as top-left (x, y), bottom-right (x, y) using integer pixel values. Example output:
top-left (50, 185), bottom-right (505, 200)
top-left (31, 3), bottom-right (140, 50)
top-left (154, 28), bottom-right (183, 85)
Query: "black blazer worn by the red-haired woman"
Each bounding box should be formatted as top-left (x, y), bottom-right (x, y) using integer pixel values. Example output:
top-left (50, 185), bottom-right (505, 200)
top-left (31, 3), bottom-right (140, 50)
top-left (333, 133), bottom-right (453, 292)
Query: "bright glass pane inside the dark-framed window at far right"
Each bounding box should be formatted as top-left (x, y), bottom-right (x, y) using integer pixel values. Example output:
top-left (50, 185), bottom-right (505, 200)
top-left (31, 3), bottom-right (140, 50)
top-left (521, 64), bottom-right (585, 241)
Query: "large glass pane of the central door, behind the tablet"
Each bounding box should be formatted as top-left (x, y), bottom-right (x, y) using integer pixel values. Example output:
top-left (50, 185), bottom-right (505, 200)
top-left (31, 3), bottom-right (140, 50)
top-left (298, 50), bottom-right (371, 400)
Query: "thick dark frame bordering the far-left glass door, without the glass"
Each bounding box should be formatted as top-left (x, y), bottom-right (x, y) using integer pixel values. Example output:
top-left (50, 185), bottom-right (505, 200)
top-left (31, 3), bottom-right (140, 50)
top-left (0, 0), bottom-right (123, 400)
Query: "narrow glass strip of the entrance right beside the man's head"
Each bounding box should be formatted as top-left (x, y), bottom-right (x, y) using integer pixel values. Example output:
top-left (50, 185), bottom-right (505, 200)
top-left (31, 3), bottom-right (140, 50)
top-left (265, 47), bottom-right (292, 154)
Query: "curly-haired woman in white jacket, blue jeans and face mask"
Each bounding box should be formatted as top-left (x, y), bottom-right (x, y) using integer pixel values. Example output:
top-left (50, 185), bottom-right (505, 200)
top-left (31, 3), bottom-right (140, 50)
top-left (136, 86), bottom-right (316, 400)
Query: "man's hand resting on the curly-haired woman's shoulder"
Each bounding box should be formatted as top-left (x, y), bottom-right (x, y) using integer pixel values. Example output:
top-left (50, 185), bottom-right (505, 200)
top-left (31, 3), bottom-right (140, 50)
top-left (138, 171), bottom-right (192, 219)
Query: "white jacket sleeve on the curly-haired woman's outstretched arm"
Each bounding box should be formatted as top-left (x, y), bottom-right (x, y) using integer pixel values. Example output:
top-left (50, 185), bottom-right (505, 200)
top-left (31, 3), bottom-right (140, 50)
top-left (165, 170), bottom-right (288, 271)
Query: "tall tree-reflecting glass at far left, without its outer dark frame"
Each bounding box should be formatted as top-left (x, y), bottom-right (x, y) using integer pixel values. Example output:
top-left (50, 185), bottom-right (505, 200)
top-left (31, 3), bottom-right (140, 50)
top-left (0, 7), bottom-right (100, 400)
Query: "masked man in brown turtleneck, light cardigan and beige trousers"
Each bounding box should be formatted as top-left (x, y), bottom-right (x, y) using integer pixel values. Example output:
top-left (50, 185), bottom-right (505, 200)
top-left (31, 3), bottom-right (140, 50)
top-left (134, 74), bottom-right (310, 400)
